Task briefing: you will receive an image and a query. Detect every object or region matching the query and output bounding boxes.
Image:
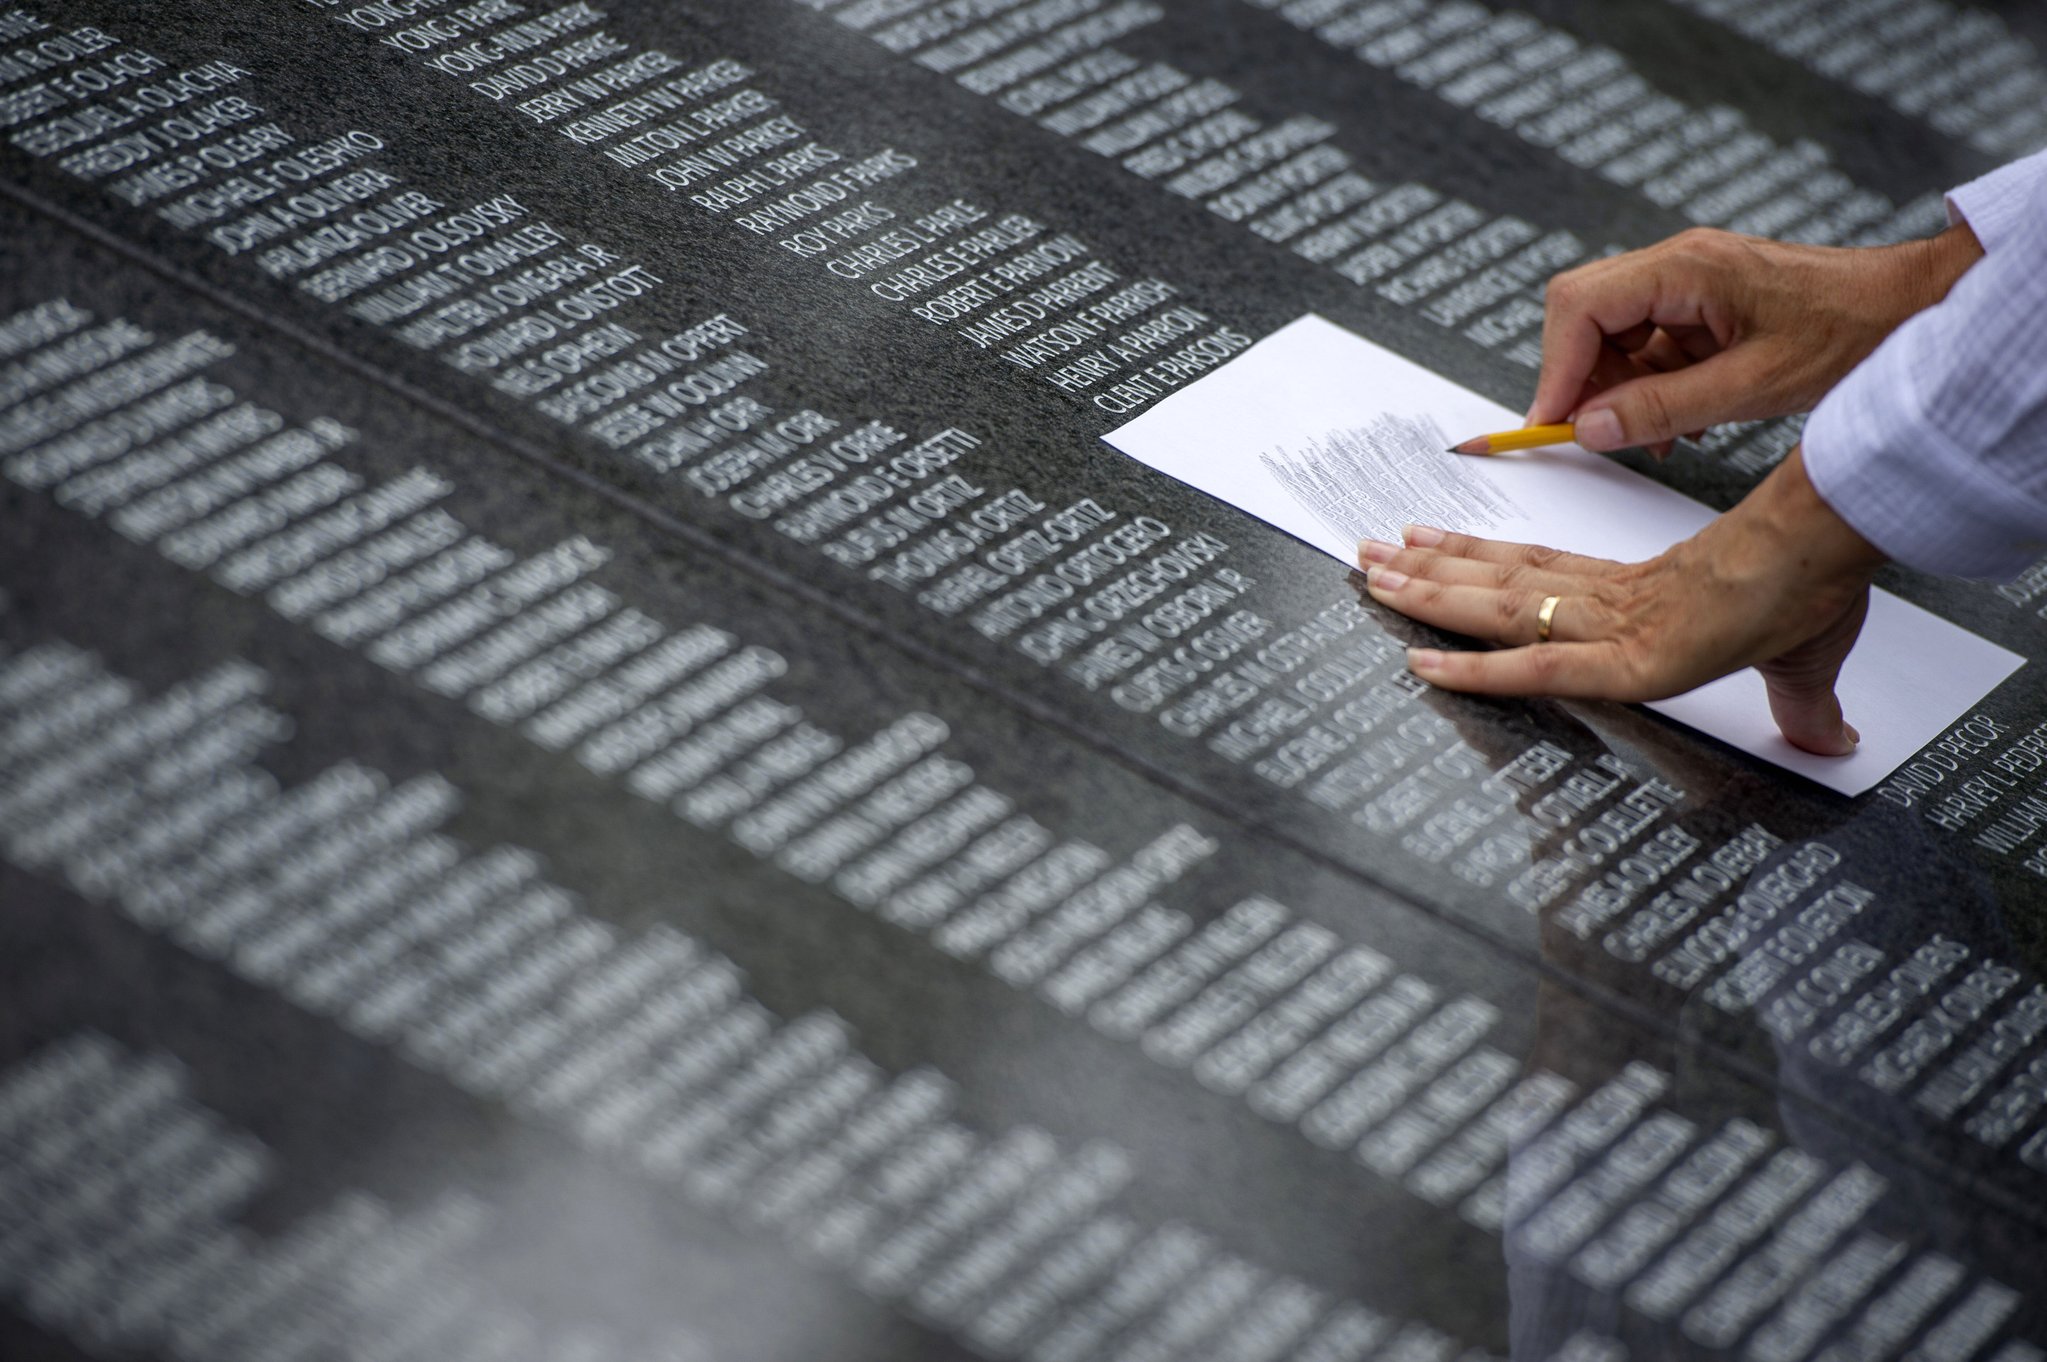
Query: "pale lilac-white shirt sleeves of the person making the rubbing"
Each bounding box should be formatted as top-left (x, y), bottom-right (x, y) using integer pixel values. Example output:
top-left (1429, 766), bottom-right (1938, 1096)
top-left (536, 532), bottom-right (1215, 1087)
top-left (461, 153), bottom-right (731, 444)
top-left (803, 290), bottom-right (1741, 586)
top-left (1803, 152), bottom-right (2047, 578)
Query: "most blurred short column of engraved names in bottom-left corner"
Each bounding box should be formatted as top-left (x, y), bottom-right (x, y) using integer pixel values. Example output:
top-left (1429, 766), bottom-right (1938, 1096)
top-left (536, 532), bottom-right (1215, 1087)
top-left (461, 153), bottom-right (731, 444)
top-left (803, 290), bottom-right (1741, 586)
top-left (0, 1032), bottom-right (710, 1362)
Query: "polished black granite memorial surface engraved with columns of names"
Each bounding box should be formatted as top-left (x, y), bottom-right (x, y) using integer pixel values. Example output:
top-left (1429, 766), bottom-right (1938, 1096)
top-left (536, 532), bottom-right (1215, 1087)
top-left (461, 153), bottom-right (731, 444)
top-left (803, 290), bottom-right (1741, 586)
top-left (0, 0), bottom-right (2047, 1362)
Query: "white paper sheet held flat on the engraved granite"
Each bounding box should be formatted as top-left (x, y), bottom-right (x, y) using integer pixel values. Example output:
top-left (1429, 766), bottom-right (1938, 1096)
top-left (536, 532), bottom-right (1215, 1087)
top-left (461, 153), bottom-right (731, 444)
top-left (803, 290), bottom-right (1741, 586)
top-left (1103, 313), bottom-right (2024, 795)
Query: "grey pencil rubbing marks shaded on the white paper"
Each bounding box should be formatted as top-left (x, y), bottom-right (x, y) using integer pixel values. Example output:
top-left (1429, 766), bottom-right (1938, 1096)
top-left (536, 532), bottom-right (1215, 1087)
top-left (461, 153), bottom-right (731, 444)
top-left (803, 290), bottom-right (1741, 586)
top-left (1259, 414), bottom-right (1527, 543)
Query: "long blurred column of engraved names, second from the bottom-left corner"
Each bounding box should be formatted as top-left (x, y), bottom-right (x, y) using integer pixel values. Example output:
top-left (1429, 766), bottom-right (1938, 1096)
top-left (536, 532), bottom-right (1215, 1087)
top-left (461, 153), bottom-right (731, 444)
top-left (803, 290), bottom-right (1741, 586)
top-left (0, 630), bottom-right (1547, 1358)
